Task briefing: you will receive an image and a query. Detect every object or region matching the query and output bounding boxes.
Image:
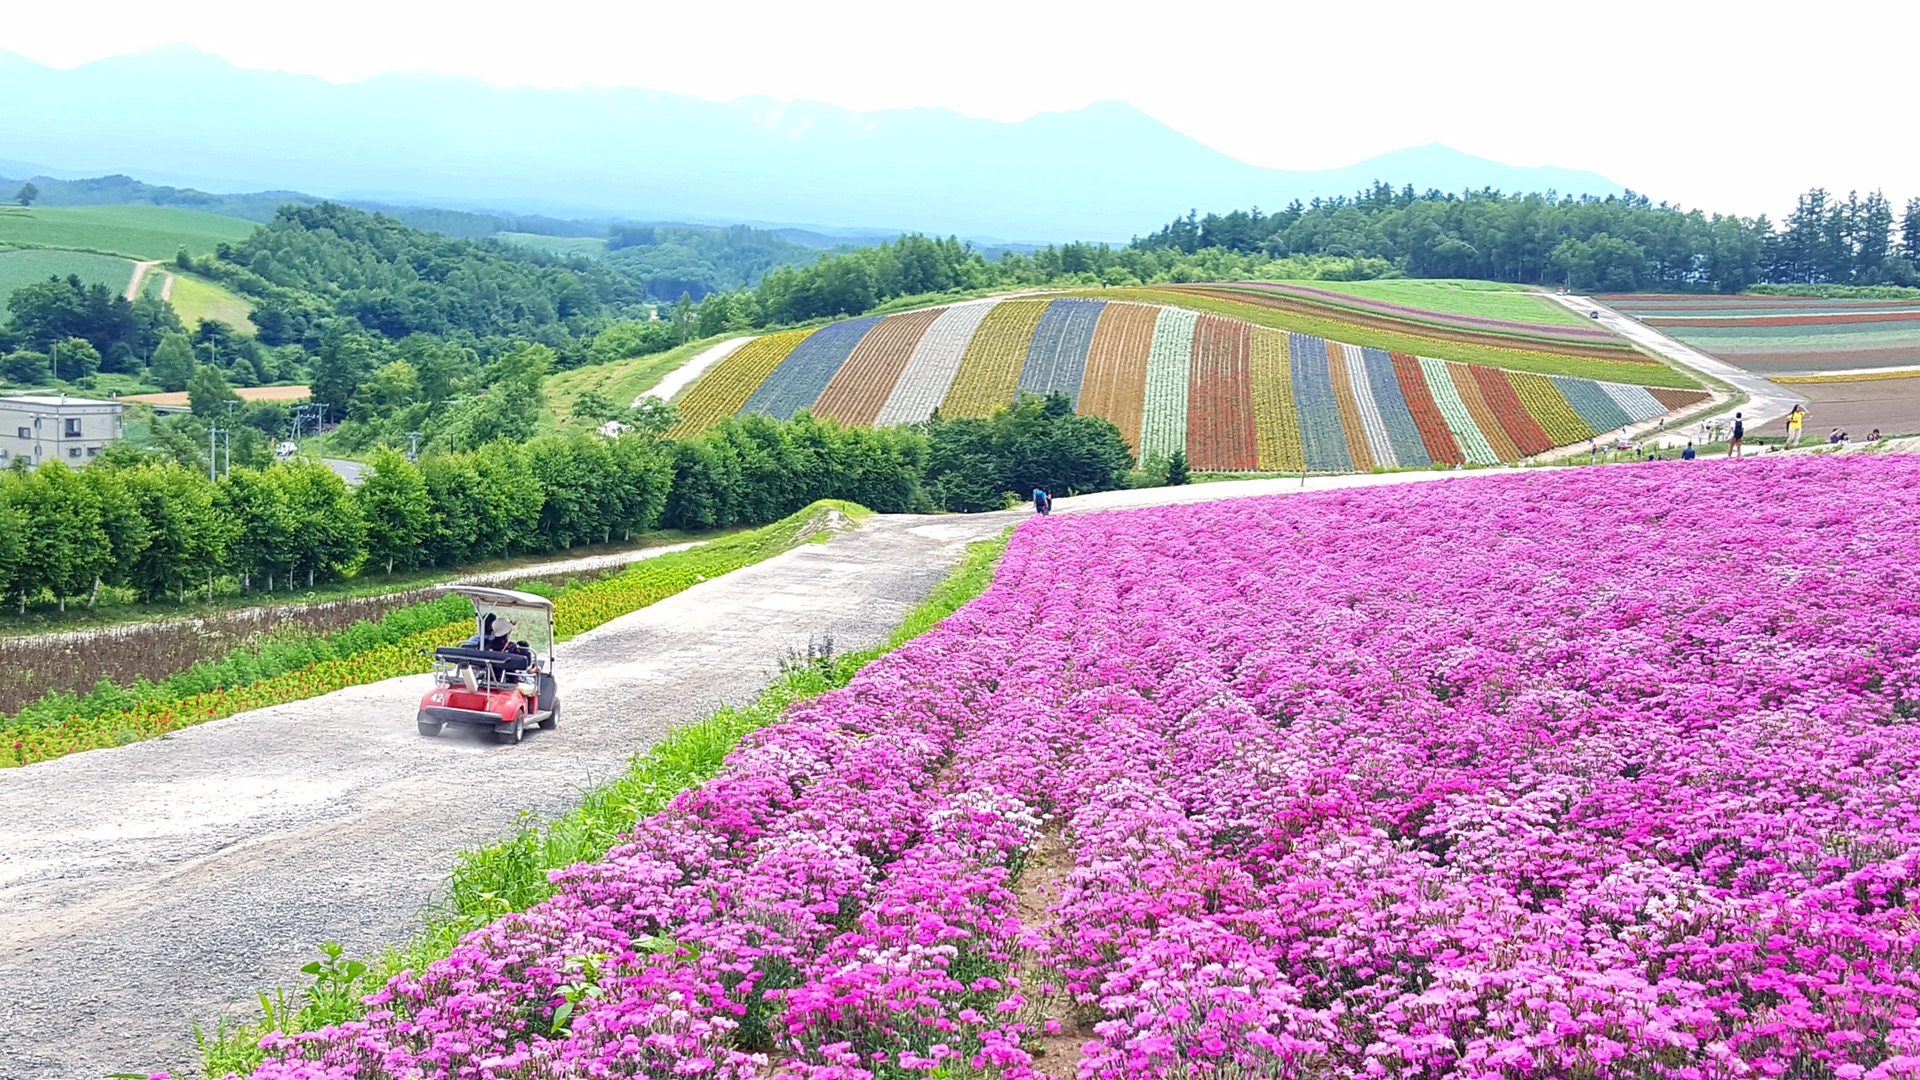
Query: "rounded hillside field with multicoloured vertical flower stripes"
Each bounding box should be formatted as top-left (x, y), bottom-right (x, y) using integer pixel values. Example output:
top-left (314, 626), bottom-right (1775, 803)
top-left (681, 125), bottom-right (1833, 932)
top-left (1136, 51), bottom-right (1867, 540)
top-left (676, 290), bottom-right (1707, 471)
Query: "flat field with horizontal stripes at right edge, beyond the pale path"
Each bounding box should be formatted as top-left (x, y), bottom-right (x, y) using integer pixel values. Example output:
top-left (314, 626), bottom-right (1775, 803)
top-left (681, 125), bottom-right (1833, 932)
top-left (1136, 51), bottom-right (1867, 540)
top-left (1597, 294), bottom-right (1920, 375)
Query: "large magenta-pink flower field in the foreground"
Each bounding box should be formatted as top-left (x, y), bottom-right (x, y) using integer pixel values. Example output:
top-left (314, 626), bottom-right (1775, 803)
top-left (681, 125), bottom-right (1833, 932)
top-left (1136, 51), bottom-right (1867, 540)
top-left (257, 457), bottom-right (1920, 1080)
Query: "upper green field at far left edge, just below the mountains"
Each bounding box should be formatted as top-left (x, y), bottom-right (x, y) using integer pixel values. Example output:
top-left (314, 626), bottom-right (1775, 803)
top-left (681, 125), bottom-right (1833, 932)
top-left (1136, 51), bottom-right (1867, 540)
top-left (0, 206), bottom-right (257, 259)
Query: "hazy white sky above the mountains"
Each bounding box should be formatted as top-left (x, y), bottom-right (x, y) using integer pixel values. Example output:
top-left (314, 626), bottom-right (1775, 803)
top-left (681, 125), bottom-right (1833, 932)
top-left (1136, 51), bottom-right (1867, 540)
top-left (0, 0), bottom-right (1920, 213)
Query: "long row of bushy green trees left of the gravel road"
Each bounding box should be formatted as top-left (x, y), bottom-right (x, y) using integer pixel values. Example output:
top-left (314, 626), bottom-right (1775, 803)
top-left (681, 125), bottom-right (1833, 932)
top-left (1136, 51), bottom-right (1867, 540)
top-left (0, 394), bottom-right (1131, 611)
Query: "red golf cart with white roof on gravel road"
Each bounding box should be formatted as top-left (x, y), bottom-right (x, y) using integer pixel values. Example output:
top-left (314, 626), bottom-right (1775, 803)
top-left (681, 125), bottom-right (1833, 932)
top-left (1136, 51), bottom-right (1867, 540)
top-left (417, 584), bottom-right (561, 744)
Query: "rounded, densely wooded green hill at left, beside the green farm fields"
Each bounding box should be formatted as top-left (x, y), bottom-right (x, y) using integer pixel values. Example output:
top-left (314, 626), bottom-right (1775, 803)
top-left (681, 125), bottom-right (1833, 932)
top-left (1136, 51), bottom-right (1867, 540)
top-left (209, 202), bottom-right (641, 344)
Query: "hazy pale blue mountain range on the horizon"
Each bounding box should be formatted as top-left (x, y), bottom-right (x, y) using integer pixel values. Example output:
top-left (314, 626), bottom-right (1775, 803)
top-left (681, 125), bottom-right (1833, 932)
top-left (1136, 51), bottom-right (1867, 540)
top-left (0, 46), bottom-right (1622, 240)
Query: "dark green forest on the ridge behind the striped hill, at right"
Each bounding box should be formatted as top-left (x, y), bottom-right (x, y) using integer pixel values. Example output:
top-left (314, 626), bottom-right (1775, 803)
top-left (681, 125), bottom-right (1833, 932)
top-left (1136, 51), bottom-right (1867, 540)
top-left (1131, 184), bottom-right (1920, 292)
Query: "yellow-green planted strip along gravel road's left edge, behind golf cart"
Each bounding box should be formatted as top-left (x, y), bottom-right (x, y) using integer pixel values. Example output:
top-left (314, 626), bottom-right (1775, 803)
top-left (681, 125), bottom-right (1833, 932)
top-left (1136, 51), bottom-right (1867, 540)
top-left (0, 500), bottom-right (870, 767)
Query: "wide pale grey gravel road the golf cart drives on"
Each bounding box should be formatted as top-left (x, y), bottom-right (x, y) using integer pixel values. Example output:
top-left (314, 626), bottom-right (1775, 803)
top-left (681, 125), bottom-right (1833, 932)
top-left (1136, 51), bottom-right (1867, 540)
top-left (0, 513), bottom-right (1020, 1080)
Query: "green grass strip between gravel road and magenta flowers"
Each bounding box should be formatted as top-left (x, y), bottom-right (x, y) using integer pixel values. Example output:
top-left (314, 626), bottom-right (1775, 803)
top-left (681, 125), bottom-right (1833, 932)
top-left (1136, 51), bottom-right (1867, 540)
top-left (194, 528), bottom-right (1012, 1076)
